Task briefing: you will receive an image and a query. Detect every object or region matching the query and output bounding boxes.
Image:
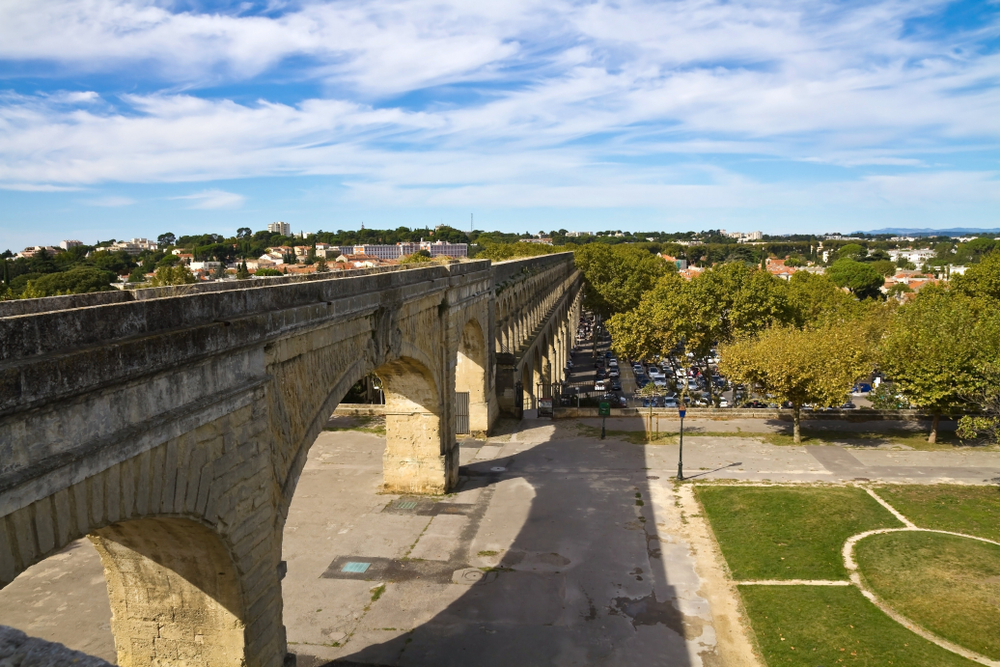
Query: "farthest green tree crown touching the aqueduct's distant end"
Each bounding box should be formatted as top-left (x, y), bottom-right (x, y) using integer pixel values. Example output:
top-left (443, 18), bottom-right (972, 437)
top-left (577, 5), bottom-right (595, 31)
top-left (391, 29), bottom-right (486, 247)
top-left (575, 243), bottom-right (670, 317)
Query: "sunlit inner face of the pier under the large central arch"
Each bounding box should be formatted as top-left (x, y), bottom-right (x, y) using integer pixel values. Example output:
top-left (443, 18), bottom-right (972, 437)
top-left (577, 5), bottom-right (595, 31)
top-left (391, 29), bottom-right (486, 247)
top-left (375, 356), bottom-right (458, 493)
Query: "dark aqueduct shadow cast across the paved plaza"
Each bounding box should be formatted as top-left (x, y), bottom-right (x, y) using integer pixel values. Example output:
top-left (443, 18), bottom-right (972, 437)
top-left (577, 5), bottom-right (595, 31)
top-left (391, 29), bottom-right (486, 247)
top-left (293, 420), bottom-right (700, 667)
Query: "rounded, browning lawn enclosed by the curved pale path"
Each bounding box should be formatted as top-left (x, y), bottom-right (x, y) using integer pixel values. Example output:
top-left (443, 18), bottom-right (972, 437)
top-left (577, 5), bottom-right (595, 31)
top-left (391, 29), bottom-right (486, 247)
top-left (855, 532), bottom-right (1000, 660)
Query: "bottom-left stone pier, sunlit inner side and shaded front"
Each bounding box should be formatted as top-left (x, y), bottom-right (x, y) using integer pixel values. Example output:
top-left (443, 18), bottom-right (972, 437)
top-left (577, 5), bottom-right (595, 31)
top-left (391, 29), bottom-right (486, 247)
top-left (91, 514), bottom-right (285, 667)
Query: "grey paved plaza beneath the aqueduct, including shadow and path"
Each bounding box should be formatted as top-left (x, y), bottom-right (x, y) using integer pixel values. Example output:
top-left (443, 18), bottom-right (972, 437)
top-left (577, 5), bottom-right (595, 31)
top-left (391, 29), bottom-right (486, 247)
top-left (0, 418), bottom-right (1000, 667)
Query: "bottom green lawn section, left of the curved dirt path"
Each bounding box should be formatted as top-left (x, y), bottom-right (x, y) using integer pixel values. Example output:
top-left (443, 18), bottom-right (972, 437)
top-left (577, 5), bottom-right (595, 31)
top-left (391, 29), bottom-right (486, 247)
top-left (740, 586), bottom-right (977, 667)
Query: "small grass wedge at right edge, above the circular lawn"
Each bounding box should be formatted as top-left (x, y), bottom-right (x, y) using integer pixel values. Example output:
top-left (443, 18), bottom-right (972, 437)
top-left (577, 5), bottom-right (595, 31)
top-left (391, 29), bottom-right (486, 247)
top-left (876, 484), bottom-right (1000, 542)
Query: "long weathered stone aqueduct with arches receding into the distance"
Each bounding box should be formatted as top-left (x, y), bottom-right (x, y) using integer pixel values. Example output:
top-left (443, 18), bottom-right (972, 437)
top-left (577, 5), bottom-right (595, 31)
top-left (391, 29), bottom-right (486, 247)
top-left (0, 254), bottom-right (581, 667)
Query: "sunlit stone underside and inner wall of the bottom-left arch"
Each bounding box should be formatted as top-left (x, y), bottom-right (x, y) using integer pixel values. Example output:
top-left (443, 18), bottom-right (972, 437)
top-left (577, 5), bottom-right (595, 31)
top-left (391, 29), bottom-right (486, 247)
top-left (88, 517), bottom-right (248, 667)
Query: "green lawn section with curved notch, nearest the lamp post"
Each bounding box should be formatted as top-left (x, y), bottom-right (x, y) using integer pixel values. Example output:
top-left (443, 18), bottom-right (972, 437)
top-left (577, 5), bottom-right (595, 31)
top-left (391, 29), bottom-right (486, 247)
top-left (695, 486), bottom-right (902, 581)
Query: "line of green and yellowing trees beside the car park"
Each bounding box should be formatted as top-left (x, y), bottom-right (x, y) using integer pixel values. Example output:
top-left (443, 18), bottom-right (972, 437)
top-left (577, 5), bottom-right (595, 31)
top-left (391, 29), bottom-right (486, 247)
top-left (576, 246), bottom-right (1000, 442)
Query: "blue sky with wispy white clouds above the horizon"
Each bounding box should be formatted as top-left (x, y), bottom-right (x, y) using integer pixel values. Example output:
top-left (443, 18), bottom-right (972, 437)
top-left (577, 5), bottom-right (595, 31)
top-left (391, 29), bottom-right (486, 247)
top-left (0, 0), bottom-right (1000, 250)
